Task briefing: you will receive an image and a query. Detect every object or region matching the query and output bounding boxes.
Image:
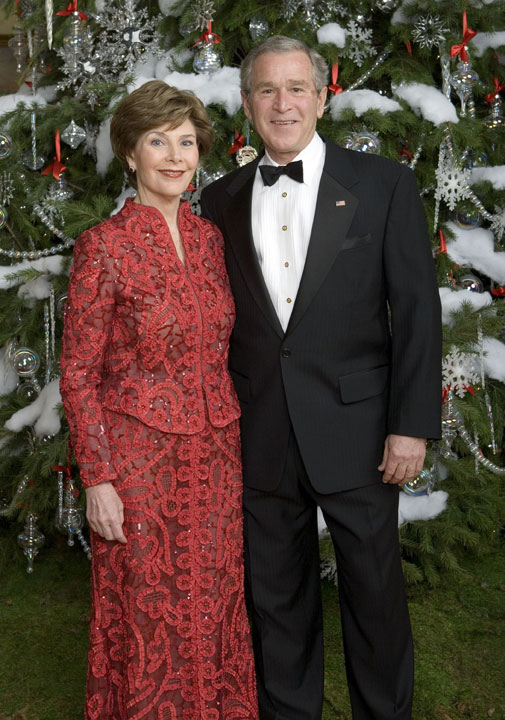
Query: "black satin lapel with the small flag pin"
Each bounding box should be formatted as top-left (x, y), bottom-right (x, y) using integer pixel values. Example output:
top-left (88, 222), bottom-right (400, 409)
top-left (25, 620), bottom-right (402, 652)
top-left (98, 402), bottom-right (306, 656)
top-left (286, 151), bottom-right (359, 333)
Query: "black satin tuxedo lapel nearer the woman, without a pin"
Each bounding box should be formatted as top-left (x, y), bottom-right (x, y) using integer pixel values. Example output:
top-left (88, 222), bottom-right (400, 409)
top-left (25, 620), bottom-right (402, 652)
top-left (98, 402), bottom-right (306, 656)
top-left (224, 162), bottom-right (284, 338)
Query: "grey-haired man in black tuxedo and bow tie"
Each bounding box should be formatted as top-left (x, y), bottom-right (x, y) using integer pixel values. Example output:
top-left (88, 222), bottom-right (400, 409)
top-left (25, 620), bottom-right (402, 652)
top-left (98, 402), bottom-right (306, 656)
top-left (202, 36), bottom-right (441, 720)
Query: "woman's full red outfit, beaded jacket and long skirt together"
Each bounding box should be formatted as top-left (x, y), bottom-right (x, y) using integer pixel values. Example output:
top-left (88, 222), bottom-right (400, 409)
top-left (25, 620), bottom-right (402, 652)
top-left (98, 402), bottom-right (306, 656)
top-left (61, 200), bottom-right (258, 720)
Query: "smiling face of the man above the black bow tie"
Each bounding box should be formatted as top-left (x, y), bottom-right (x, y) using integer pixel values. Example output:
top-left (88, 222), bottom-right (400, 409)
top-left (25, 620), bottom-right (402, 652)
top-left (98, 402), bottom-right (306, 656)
top-left (242, 51), bottom-right (327, 165)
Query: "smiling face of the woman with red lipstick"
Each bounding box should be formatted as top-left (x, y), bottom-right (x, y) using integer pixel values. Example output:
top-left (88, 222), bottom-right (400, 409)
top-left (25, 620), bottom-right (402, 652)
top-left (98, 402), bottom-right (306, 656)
top-left (127, 119), bottom-right (199, 208)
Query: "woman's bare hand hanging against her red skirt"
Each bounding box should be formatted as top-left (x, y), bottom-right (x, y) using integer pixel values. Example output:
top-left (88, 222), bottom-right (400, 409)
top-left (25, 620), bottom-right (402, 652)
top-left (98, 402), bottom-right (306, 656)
top-left (86, 482), bottom-right (126, 543)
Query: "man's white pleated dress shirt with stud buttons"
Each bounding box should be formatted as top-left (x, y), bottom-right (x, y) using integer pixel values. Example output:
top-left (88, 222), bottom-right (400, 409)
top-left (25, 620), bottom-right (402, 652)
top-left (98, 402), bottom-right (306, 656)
top-left (251, 133), bottom-right (325, 330)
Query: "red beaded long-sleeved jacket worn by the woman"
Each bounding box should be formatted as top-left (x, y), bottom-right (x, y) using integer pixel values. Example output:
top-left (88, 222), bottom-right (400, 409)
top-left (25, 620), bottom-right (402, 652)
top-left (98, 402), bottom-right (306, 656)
top-left (60, 199), bottom-right (240, 486)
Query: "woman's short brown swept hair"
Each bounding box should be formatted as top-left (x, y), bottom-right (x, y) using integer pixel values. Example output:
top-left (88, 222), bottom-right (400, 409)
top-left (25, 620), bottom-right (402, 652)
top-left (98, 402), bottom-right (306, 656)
top-left (110, 80), bottom-right (214, 188)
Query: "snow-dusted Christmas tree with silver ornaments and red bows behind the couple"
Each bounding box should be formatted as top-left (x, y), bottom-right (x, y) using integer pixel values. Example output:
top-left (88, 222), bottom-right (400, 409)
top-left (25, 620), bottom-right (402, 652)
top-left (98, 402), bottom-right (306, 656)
top-left (0, 0), bottom-right (505, 583)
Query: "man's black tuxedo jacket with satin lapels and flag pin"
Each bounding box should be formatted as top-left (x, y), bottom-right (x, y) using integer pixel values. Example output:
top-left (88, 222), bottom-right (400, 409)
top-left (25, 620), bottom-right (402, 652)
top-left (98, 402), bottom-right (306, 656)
top-left (201, 140), bottom-right (441, 493)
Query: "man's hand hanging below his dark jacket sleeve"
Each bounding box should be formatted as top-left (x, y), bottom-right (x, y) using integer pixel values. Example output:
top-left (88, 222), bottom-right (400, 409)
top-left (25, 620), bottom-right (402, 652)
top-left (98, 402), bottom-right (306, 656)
top-left (377, 435), bottom-right (426, 485)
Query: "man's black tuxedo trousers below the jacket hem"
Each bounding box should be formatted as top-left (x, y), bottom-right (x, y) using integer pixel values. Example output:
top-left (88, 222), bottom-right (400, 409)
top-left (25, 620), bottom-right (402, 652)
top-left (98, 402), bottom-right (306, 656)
top-left (244, 432), bottom-right (413, 720)
